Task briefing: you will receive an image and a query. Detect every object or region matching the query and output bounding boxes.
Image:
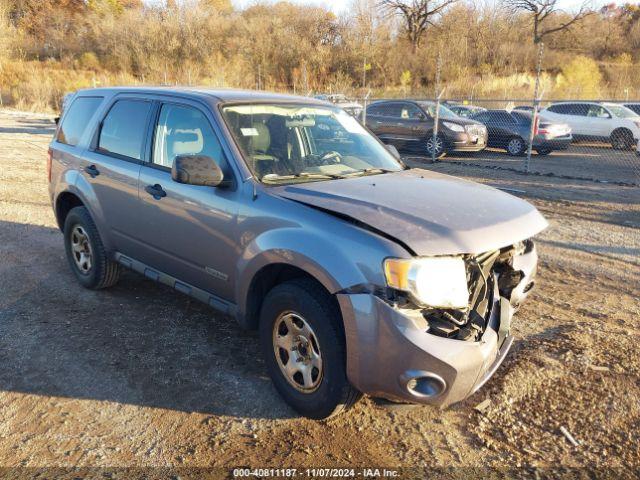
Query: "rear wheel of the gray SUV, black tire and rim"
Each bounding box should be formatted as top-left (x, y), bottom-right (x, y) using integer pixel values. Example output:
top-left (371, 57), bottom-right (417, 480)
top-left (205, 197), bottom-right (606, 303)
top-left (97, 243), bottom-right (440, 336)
top-left (64, 207), bottom-right (120, 290)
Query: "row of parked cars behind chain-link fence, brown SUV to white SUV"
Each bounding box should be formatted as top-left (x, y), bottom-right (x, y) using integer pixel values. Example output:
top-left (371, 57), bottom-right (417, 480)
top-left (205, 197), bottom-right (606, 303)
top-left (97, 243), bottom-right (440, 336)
top-left (358, 100), bottom-right (640, 158)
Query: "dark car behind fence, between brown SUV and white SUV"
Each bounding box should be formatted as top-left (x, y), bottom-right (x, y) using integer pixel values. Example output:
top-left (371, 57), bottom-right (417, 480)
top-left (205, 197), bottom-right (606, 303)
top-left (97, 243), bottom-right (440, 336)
top-left (473, 110), bottom-right (573, 156)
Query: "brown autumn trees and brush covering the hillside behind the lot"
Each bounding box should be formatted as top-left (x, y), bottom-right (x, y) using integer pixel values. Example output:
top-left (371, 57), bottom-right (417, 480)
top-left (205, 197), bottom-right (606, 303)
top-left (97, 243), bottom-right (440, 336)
top-left (0, 0), bottom-right (640, 109)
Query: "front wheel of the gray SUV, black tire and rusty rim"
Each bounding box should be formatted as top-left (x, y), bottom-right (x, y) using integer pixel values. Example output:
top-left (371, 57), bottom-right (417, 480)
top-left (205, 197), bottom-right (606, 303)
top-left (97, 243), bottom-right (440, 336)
top-left (260, 279), bottom-right (361, 420)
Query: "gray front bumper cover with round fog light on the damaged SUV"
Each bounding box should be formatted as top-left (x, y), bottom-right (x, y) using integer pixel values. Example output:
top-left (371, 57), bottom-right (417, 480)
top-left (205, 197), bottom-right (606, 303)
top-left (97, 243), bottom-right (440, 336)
top-left (337, 244), bottom-right (537, 406)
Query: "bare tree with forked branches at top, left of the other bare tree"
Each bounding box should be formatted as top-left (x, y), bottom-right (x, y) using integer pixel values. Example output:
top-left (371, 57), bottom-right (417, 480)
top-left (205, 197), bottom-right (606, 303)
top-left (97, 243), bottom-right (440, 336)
top-left (380, 0), bottom-right (458, 52)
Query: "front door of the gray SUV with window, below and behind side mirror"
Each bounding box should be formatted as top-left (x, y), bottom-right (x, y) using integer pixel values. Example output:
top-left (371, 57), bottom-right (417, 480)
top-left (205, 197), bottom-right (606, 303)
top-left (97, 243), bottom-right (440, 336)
top-left (138, 103), bottom-right (239, 301)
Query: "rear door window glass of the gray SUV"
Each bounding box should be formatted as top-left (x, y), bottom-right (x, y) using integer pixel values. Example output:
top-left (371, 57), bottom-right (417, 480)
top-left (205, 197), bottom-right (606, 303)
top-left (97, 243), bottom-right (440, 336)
top-left (98, 100), bottom-right (151, 160)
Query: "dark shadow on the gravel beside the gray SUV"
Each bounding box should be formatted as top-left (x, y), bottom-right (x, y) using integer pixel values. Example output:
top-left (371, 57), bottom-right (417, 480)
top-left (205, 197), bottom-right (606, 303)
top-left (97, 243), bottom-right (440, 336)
top-left (0, 222), bottom-right (296, 418)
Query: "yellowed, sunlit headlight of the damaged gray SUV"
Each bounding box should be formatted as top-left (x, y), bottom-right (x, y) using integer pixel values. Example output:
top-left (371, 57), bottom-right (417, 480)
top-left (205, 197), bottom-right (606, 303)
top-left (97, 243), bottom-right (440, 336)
top-left (384, 257), bottom-right (469, 309)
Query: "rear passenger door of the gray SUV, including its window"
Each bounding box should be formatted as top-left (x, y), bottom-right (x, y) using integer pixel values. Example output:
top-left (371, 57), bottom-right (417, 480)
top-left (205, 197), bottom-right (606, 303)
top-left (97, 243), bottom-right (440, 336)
top-left (81, 95), bottom-right (152, 254)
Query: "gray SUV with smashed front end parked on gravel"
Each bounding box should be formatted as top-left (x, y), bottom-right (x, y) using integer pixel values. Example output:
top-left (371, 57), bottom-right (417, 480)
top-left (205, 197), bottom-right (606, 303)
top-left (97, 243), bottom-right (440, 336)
top-left (48, 88), bottom-right (546, 418)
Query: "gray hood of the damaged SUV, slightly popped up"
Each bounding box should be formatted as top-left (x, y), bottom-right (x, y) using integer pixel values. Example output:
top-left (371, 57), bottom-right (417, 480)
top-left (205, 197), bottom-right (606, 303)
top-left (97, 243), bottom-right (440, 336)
top-left (269, 169), bottom-right (547, 255)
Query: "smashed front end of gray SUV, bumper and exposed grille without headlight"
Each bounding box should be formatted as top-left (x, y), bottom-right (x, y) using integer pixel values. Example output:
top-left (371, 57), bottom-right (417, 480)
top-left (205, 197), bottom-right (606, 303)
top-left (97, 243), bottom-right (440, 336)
top-left (338, 240), bottom-right (537, 406)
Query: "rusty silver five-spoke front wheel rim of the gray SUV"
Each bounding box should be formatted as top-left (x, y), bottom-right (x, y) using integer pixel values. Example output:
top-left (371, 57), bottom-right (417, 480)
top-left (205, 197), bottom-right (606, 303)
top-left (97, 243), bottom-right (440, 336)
top-left (272, 312), bottom-right (323, 393)
